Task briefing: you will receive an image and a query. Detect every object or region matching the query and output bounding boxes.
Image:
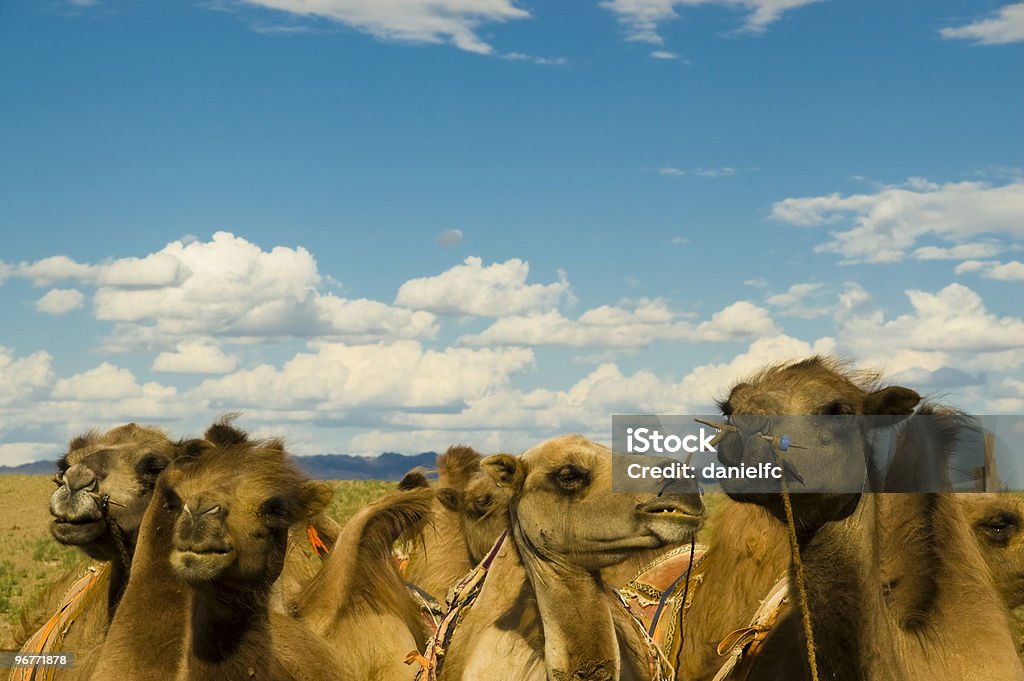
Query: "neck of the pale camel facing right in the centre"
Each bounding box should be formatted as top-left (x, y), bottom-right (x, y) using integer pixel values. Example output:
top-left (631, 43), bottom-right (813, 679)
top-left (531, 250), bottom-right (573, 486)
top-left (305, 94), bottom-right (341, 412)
top-left (513, 524), bottom-right (620, 681)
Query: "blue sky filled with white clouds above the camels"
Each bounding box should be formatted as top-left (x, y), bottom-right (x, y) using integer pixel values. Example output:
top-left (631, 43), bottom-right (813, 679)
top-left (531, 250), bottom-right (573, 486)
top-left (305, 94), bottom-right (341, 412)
top-left (0, 0), bottom-right (1024, 464)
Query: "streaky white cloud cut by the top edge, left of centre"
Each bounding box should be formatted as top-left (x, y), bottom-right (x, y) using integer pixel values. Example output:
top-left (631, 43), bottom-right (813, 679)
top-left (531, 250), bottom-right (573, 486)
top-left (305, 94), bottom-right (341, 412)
top-left (236, 0), bottom-right (530, 54)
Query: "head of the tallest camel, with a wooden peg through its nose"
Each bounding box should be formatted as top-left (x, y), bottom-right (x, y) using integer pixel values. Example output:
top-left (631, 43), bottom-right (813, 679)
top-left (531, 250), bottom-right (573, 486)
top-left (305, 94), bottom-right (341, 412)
top-left (717, 356), bottom-right (921, 531)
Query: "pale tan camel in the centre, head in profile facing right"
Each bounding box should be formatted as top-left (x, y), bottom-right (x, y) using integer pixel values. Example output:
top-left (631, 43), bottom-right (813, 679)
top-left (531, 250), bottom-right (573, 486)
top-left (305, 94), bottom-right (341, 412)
top-left (432, 435), bottom-right (703, 681)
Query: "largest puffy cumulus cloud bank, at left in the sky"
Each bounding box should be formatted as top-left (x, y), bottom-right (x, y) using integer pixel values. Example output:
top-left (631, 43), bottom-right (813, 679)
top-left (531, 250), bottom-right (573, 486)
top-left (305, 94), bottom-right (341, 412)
top-left (8, 231), bottom-right (437, 352)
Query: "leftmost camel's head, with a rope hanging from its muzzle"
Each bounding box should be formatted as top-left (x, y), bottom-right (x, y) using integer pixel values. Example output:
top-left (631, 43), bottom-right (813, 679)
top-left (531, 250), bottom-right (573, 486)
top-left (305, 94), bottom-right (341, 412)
top-left (50, 423), bottom-right (180, 560)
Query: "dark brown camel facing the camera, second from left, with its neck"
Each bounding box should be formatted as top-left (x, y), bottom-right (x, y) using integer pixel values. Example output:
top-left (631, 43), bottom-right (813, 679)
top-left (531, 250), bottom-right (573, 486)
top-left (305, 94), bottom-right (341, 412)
top-left (91, 418), bottom-right (347, 681)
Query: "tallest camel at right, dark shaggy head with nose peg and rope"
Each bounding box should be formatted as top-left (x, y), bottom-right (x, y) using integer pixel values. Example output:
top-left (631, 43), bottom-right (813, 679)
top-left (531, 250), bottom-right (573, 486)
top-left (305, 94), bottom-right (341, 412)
top-left (718, 356), bottom-right (1024, 681)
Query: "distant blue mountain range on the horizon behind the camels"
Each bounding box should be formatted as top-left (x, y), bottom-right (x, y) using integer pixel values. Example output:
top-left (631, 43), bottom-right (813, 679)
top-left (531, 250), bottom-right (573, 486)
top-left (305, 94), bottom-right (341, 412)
top-left (0, 452), bottom-right (437, 480)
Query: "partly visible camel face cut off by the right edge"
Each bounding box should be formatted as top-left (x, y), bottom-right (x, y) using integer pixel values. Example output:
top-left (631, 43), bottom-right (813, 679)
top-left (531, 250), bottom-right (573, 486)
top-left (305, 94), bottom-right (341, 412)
top-left (957, 493), bottom-right (1024, 608)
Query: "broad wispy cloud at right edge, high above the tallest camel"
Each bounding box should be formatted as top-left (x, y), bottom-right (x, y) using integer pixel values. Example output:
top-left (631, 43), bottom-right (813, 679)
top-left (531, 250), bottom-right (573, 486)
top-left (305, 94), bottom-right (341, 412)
top-left (772, 178), bottom-right (1024, 263)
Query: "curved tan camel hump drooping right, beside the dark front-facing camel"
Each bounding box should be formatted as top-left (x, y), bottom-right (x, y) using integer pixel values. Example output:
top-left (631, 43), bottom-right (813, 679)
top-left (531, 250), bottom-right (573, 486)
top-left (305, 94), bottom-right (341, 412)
top-left (293, 488), bottom-right (434, 681)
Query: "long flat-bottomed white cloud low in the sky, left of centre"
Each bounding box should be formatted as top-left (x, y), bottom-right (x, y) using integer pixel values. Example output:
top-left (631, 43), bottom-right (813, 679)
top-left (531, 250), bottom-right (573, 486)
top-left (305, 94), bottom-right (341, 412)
top-left (193, 341), bottom-right (534, 411)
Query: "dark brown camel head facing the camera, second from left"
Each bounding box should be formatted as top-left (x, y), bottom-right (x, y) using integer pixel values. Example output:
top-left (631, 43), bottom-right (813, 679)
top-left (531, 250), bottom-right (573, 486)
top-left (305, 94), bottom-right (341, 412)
top-left (161, 422), bottom-right (332, 591)
